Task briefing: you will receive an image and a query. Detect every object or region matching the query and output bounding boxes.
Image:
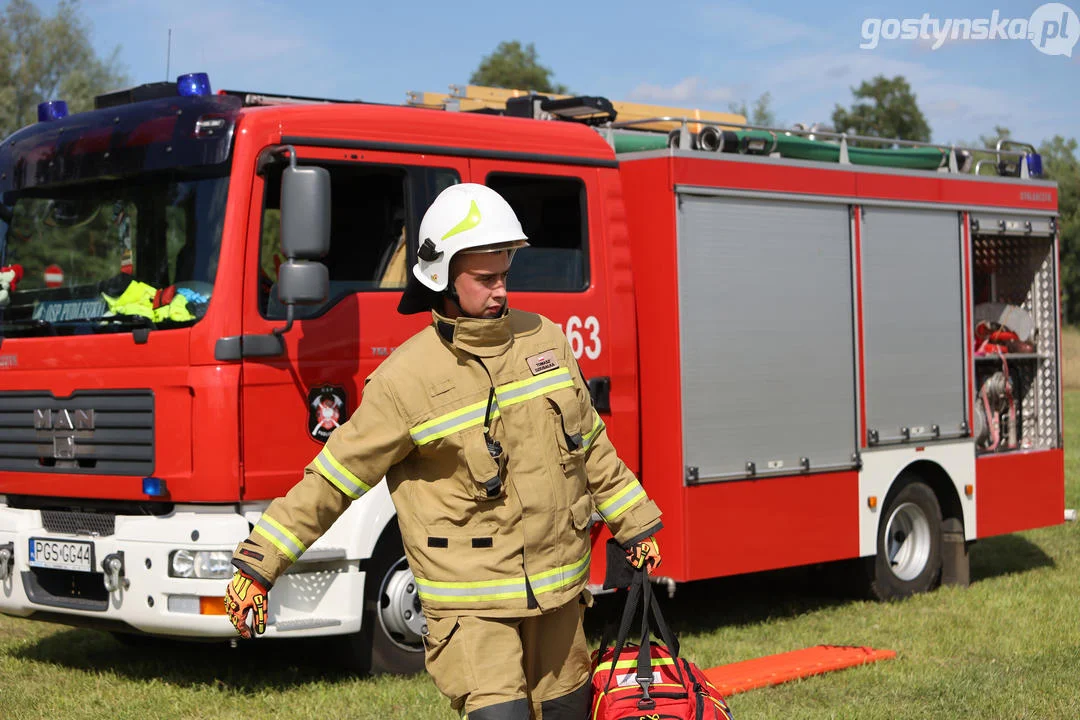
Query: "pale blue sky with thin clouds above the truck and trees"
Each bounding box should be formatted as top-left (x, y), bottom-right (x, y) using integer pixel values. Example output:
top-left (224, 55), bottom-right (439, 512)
top-left (37, 0), bottom-right (1080, 145)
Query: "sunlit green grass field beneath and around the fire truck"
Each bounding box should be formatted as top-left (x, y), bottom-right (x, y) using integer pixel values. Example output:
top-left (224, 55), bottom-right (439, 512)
top-left (0, 369), bottom-right (1080, 720)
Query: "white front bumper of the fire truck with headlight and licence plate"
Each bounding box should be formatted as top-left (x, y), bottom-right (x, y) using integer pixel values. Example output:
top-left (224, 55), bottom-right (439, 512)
top-left (0, 503), bottom-right (364, 639)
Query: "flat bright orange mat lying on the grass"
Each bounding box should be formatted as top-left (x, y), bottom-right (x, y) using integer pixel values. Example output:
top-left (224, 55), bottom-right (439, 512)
top-left (705, 646), bottom-right (896, 695)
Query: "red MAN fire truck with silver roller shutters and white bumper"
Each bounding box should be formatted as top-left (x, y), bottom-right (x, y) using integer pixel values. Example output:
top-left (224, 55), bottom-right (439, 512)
top-left (0, 76), bottom-right (1064, 670)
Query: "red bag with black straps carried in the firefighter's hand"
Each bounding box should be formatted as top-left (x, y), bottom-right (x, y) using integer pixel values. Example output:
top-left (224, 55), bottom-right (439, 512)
top-left (590, 570), bottom-right (731, 720)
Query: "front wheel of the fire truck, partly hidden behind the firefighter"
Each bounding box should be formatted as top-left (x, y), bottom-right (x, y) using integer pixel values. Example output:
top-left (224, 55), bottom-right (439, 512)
top-left (342, 520), bottom-right (427, 675)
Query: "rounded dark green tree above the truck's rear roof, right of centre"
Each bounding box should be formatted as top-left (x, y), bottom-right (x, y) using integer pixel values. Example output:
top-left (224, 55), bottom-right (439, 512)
top-left (833, 74), bottom-right (930, 142)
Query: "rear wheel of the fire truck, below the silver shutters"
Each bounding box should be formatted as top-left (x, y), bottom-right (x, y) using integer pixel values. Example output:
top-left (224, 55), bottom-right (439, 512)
top-left (869, 480), bottom-right (942, 600)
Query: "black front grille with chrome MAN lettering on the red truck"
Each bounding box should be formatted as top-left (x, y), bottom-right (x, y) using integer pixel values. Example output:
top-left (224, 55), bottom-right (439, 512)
top-left (0, 390), bottom-right (153, 475)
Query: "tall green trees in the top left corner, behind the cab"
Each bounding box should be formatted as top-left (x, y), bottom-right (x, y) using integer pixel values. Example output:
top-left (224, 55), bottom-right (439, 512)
top-left (0, 0), bottom-right (127, 137)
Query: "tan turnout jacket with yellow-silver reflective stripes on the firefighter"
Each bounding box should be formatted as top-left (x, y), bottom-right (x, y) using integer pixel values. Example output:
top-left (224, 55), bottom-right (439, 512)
top-left (233, 310), bottom-right (660, 617)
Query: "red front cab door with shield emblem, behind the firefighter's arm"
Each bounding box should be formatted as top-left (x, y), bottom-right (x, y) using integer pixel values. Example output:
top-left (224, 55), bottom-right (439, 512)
top-left (241, 147), bottom-right (468, 501)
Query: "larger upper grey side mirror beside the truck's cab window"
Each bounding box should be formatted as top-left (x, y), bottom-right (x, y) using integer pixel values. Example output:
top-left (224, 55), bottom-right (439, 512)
top-left (281, 165), bottom-right (330, 260)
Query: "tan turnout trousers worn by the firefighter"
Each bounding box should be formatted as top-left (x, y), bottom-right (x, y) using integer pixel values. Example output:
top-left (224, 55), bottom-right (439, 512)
top-left (424, 593), bottom-right (592, 720)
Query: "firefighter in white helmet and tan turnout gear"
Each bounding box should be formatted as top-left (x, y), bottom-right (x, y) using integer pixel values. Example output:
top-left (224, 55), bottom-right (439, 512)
top-left (226, 184), bottom-right (661, 720)
